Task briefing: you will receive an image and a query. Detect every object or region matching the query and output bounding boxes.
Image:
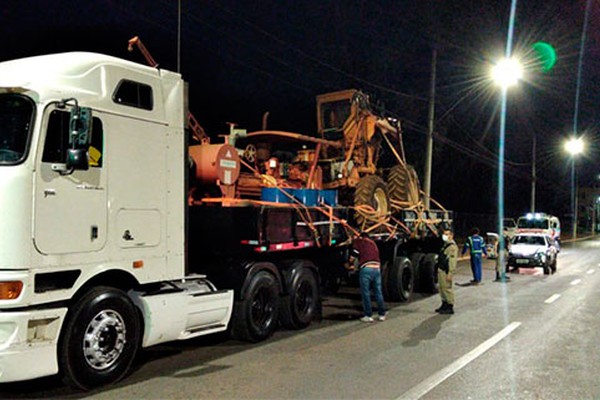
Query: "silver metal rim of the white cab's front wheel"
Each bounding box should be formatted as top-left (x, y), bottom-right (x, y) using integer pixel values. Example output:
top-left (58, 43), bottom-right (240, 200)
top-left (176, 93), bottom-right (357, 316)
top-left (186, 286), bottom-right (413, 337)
top-left (83, 310), bottom-right (127, 370)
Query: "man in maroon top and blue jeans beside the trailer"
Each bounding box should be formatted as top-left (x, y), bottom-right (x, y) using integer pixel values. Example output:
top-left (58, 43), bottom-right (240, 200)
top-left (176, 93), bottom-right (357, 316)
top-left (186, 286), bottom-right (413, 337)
top-left (349, 232), bottom-right (386, 322)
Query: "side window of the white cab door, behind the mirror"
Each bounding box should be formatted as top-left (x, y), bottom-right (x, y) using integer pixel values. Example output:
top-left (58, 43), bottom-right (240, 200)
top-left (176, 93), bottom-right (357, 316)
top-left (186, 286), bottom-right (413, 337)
top-left (42, 110), bottom-right (104, 167)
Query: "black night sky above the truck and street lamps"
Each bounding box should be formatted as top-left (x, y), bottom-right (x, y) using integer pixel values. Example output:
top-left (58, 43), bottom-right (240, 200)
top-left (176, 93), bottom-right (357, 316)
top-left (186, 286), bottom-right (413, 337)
top-left (0, 0), bottom-right (600, 216)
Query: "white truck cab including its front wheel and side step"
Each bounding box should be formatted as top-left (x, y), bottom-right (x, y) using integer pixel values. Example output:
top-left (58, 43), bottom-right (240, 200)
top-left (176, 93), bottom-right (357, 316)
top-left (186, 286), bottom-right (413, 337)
top-left (0, 53), bottom-right (233, 389)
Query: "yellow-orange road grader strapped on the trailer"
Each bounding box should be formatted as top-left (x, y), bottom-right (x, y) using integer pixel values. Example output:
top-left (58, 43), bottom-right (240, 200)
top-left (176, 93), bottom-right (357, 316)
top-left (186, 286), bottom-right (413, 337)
top-left (236, 89), bottom-right (422, 227)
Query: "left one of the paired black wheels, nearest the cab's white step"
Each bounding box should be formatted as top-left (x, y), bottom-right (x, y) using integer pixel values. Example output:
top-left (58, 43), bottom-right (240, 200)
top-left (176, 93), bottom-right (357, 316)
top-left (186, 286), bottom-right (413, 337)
top-left (231, 271), bottom-right (279, 343)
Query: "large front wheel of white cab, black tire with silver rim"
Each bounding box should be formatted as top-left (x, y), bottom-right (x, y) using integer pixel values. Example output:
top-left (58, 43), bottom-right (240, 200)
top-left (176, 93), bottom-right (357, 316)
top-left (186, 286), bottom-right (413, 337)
top-left (58, 286), bottom-right (141, 390)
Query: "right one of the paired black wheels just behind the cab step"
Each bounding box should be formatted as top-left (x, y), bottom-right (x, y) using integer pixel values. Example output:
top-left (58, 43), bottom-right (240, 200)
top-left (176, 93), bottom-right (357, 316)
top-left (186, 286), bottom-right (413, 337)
top-left (279, 268), bottom-right (320, 329)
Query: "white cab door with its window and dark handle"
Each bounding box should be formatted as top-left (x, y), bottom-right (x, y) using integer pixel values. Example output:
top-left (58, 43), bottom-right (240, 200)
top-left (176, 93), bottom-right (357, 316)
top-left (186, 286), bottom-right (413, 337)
top-left (34, 107), bottom-right (107, 254)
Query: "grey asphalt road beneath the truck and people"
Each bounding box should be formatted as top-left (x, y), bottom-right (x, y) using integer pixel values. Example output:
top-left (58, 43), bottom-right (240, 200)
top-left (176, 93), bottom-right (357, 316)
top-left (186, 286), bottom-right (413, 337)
top-left (0, 239), bottom-right (600, 399)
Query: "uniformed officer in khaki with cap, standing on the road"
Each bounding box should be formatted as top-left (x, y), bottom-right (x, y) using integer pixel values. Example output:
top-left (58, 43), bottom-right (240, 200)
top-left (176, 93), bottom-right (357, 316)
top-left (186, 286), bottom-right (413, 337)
top-left (435, 229), bottom-right (458, 314)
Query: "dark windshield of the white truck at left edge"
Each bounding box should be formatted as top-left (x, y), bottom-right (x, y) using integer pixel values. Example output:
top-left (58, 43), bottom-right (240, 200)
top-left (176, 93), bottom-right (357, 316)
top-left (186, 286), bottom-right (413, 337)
top-left (0, 94), bottom-right (34, 166)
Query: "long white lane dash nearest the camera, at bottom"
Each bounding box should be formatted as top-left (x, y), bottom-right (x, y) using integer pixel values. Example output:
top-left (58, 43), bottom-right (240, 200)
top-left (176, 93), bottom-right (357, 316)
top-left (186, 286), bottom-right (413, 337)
top-left (396, 322), bottom-right (521, 400)
